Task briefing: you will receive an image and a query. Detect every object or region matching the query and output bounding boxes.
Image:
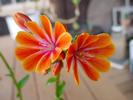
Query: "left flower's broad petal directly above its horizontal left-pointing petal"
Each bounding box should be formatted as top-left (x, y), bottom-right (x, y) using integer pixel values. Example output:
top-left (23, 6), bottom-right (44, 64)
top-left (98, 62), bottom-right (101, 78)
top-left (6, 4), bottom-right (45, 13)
top-left (16, 31), bottom-right (39, 46)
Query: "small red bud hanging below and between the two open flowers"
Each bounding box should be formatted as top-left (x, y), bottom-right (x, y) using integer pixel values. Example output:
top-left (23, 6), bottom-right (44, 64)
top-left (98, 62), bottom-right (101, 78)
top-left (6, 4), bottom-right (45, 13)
top-left (52, 60), bottom-right (63, 75)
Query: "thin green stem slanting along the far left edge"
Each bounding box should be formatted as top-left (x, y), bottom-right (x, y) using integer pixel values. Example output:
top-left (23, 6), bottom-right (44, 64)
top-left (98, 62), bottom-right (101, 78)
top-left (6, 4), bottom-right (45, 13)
top-left (0, 51), bottom-right (23, 100)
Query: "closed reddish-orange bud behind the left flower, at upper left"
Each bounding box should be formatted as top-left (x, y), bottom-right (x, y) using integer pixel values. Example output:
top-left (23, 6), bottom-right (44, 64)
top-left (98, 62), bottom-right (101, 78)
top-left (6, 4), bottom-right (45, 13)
top-left (13, 12), bottom-right (31, 31)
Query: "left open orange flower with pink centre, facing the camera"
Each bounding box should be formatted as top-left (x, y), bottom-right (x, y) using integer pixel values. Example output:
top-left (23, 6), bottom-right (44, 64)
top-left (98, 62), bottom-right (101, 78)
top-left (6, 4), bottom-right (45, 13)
top-left (15, 15), bottom-right (72, 73)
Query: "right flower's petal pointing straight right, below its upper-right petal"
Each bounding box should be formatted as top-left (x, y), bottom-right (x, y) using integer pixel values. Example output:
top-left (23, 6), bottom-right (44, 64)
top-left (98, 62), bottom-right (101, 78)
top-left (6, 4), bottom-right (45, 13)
top-left (89, 44), bottom-right (115, 57)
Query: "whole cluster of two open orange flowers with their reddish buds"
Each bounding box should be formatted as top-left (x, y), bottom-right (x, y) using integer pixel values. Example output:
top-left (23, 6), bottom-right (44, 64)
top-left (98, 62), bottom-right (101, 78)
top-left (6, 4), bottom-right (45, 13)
top-left (14, 13), bottom-right (115, 84)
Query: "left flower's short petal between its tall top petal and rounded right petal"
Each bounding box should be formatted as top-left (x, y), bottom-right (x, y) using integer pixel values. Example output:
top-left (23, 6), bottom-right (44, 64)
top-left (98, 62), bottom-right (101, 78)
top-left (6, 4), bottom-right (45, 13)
top-left (54, 22), bottom-right (66, 40)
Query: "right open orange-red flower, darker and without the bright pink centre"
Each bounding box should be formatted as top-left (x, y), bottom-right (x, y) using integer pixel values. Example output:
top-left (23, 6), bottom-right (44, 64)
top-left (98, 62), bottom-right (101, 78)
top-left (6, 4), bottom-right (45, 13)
top-left (66, 33), bottom-right (114, 85)
